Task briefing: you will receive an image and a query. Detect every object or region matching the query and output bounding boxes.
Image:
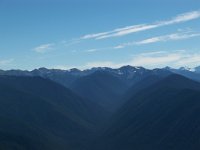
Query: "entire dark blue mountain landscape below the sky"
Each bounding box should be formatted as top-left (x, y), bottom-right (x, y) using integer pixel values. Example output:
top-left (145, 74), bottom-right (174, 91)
top-left (0, 66), bottom-right (200, 150)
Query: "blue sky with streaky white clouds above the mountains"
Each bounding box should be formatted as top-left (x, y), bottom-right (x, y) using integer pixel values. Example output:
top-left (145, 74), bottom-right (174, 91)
top-left (0, 0), bottom-right (200, 70)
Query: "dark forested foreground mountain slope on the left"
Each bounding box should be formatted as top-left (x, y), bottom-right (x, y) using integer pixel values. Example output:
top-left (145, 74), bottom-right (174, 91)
top-left (0, 76), bottom-right (105, 150)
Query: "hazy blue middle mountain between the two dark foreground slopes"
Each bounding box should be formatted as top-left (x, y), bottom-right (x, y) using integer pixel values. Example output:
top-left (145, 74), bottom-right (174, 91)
top-left (72, 71), bottom-right (128, 111)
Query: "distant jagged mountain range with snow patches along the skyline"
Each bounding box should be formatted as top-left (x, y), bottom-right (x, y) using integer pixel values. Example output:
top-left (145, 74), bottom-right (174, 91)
top-left (0, 66), bottom-right (200, 85)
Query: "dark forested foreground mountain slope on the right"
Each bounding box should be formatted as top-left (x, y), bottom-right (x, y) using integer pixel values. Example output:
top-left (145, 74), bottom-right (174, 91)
top-left (96, 75), bottom-right (200, 150)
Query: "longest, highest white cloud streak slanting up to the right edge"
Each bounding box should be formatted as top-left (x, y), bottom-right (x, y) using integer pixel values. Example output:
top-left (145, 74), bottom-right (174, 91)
top-left (80, 11), bottom-right (200, 40)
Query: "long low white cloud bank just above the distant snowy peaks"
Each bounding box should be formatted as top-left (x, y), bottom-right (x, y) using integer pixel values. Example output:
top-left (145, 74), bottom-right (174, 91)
top-left (82, 50), bottom-right (200, 68)
